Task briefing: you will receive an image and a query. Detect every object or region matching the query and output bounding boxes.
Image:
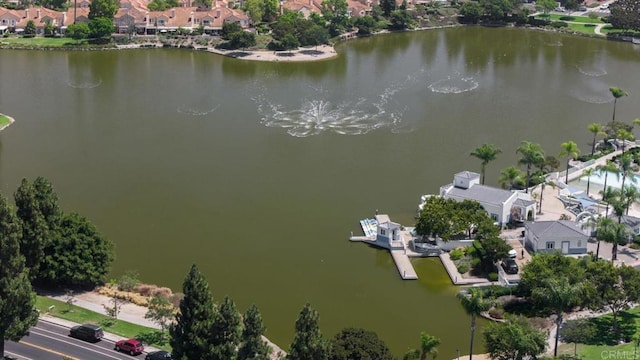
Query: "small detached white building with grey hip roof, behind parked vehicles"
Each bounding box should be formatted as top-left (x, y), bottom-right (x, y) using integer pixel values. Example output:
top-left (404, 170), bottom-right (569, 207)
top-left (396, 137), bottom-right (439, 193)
top-left (524, 220), bottom-right (589, 255)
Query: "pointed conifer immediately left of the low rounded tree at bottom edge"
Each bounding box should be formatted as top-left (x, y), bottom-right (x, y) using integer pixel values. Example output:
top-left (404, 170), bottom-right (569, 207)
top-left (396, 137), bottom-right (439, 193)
top-left (287, 304), bottom-right (329, 360)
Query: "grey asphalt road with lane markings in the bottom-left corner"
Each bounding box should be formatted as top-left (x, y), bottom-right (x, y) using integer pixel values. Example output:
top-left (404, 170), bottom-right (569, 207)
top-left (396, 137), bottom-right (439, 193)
top-left (5, 321), bottom-right (144, 360)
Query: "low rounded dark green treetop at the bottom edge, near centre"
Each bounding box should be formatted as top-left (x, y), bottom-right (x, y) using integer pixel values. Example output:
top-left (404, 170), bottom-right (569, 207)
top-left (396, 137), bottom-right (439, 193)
top-left (329, 328), bottom-right (394, 360)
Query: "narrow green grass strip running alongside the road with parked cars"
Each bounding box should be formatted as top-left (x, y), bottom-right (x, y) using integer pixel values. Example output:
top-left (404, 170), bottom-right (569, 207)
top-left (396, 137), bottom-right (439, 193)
top-left (36, 296), bottom-right (170, 350)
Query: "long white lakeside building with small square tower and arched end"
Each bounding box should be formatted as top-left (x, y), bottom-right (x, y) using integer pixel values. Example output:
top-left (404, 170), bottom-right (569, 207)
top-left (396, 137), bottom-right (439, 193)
top-left (440, 171), bottom-right (536, 226)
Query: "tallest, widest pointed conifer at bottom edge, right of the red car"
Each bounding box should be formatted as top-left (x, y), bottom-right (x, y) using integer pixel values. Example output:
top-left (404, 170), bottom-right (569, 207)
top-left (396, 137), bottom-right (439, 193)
top-left (169, 264), bottom-right (216, 360)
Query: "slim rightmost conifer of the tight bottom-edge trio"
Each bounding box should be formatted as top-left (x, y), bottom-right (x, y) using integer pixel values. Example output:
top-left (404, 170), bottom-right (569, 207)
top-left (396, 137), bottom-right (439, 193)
top-left (238, 304), bottom-right (271, 360)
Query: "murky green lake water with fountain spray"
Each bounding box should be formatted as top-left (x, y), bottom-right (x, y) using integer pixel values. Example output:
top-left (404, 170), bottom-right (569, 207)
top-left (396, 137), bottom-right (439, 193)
top-left (0, 27), bottom-right (640, 359)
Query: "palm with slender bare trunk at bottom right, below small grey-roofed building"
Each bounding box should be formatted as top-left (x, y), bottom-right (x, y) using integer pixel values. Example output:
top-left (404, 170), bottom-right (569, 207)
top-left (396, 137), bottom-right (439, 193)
top-left (532, 277), bottom-right (582, 357)
